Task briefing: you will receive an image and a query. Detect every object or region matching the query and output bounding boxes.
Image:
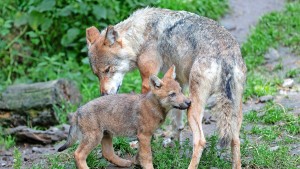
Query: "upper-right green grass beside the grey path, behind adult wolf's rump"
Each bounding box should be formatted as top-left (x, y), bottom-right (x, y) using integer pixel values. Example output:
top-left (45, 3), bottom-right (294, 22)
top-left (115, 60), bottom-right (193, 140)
top-left (241, 1), bottom-right (300, 100)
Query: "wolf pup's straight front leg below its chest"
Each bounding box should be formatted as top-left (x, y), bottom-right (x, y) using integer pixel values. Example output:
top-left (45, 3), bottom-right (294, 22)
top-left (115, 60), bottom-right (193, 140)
top-left (138, 134), bottom-right (153, 169)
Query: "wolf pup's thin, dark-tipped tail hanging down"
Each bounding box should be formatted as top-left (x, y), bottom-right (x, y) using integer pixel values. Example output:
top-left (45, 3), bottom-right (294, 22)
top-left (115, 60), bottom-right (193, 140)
top-left (57, 113), bottom-right (78, 152)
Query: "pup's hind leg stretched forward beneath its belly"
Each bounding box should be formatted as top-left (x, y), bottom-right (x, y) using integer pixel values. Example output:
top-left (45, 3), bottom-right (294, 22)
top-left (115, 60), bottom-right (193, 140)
top-left (101, 134), bottom-right (131, 167)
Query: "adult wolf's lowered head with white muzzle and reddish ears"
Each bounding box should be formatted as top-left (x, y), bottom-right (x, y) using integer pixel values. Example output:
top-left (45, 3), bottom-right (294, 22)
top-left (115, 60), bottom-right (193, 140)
top-left (86, 26), bottom-right (135, 95)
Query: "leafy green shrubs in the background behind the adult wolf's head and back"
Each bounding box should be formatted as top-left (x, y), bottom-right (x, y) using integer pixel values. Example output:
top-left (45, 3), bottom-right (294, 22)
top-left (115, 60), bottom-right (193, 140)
top-left (0, 0), bottom-right (228, 100)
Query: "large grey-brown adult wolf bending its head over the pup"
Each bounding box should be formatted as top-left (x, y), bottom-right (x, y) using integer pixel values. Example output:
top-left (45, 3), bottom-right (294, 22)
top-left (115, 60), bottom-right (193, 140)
top-left (86, 8), bottom-right (246, 169)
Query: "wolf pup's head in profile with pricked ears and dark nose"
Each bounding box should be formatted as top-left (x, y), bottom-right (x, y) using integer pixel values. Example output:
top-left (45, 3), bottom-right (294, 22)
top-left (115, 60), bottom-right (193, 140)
top-left (149, 65), bottom-right (191, 110)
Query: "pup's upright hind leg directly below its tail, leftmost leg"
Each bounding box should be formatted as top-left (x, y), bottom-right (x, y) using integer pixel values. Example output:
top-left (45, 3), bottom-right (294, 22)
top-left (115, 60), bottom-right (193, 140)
top-left (74, 131), bottom-right (103, 169)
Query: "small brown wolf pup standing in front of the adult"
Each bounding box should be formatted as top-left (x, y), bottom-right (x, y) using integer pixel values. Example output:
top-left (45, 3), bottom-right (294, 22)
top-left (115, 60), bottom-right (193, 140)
top-left (58, 66), bottom-right (191, 169)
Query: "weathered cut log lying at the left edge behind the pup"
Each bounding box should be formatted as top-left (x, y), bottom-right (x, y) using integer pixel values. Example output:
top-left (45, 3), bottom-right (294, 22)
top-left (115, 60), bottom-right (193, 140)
top-left (0, 79), bottom-right (81, 127)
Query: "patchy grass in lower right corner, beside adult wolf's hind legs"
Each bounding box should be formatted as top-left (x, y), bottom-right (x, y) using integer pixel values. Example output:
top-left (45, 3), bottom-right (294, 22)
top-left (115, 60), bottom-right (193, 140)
top-left (241, 99), bottom-right (300, 169)
